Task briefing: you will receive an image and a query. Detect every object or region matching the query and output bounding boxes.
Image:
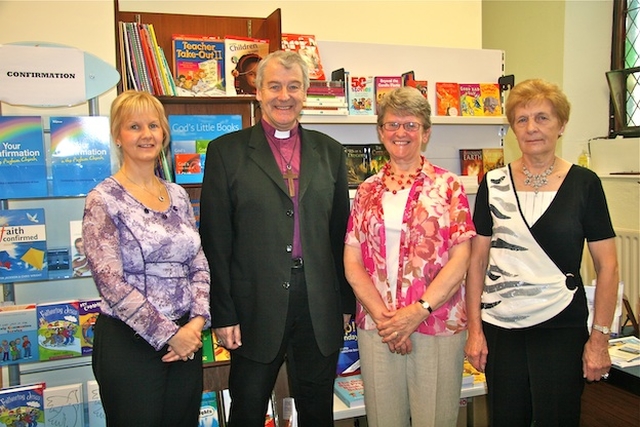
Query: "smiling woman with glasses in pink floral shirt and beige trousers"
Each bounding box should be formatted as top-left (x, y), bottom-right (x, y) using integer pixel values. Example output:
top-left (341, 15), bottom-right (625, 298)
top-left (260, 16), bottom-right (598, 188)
top-left (344, 87), bottom-right (475, 427)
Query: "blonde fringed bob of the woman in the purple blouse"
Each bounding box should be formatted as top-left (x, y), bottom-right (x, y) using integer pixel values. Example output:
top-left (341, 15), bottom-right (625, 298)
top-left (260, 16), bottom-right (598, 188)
top-left (110, 90), bottom-right (170, 161)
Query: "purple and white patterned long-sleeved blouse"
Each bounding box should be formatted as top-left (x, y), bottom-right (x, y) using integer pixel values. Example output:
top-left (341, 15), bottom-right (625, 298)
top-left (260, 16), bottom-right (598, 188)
top-left (82, 177), bottom-right (211, 350)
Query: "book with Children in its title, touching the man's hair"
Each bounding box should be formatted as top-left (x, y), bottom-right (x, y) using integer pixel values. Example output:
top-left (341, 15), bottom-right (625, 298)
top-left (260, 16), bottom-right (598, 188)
top-left (224, 36), bottom-right (269, 96)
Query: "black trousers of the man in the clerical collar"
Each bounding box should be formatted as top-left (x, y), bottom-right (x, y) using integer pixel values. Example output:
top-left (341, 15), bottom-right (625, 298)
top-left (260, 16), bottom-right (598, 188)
top-left (228, 269), bottom-right (338, 427)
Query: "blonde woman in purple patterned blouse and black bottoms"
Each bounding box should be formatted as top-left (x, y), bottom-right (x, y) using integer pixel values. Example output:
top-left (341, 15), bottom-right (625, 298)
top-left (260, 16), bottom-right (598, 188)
top-left (82, 91), bottom-right (211, 427)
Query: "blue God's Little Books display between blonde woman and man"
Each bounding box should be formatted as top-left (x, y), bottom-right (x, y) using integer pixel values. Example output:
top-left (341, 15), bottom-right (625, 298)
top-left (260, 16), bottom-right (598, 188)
top-left (169, 114), bottom-right (242, 184)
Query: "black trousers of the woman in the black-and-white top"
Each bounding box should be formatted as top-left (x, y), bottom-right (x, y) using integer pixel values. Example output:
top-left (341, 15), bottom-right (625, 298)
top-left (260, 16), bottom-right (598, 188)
top-left (483, 322), bottom-right (589, 427)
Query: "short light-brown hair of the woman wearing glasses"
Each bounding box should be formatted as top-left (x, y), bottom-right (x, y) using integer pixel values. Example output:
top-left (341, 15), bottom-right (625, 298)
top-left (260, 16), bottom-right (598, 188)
top-left (378, 86), bottom-right (431, 129)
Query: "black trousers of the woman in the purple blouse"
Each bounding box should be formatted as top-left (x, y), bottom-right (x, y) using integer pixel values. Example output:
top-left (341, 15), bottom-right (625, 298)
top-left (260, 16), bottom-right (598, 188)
top-left (92, 315), bottom-right (203, 427)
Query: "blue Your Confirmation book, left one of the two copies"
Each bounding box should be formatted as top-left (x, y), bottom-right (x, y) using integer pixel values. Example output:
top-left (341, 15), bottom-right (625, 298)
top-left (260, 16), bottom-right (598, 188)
top-left (0, 116), bottom-right (49, 199)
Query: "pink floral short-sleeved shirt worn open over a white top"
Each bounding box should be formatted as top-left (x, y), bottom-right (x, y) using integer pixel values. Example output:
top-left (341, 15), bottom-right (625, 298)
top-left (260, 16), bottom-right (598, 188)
top-left (345, 159), bottom-right (476, 335)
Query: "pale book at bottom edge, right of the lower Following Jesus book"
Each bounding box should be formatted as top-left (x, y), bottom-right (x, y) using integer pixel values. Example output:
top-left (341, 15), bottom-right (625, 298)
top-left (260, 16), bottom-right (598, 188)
top-left (44, 383), bottom-right (84, 427)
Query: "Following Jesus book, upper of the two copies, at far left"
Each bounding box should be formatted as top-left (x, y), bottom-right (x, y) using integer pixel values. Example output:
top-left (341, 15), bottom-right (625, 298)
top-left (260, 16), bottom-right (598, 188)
top-left (36, 301), bottom-right (82, 361)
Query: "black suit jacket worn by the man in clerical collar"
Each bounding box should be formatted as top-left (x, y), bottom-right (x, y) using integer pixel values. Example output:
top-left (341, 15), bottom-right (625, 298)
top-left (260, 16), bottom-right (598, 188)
top-left (200, 123), bottom-right (355, 363)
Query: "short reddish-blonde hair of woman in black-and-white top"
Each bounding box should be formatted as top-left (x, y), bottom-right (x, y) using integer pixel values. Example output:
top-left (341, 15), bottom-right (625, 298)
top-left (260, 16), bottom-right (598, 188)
top-left (505, 79), bottom-right (571, 129)
